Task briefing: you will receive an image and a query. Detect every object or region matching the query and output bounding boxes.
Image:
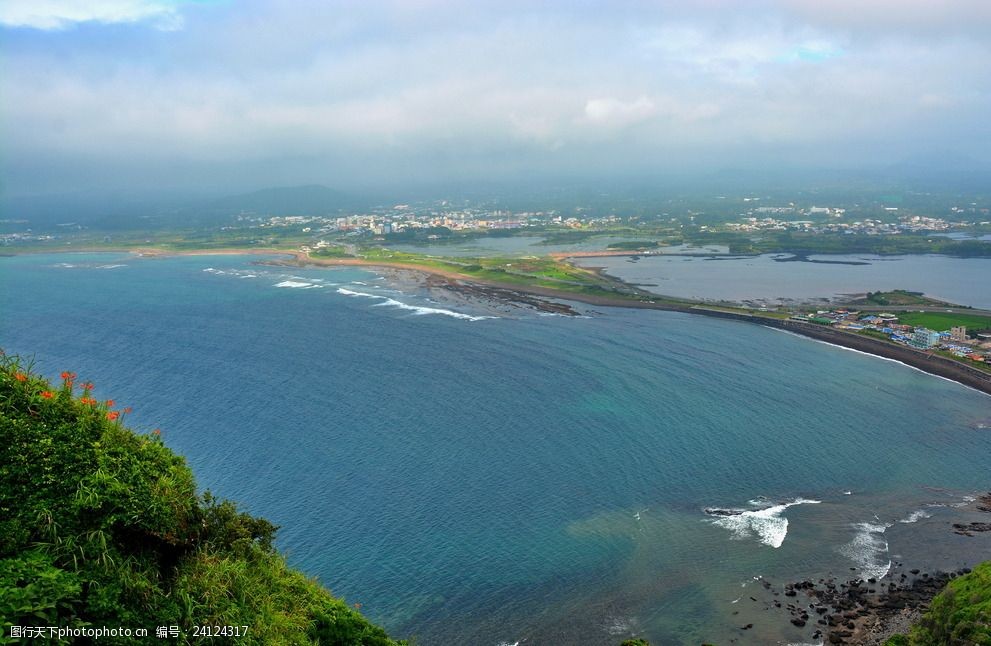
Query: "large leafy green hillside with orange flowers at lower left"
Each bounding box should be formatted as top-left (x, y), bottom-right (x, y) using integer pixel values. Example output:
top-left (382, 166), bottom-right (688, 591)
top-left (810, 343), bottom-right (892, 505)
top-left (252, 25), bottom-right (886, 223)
top-left (0, 356), bottom-right (403, 646)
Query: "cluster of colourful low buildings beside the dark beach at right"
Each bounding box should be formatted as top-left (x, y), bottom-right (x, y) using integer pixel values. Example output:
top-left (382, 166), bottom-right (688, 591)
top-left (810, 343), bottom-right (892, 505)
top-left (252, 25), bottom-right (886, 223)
top-left (791, 308), bottom-right (991, 363)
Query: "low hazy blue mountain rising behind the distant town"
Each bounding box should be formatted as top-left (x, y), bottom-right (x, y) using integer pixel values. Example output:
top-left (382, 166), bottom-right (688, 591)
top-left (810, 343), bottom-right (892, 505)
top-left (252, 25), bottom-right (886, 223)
top-left (204, 184), bottom-right (356, 215)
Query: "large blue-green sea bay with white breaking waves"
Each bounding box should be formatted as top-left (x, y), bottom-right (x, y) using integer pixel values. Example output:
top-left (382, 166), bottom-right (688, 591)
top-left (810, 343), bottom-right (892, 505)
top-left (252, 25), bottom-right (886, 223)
top-left (0, 254), bottom-right (991, 646)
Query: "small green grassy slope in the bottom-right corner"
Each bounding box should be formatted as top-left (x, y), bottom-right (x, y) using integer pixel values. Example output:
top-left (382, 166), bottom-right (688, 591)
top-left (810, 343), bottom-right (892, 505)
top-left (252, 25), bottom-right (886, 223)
top-left (885, 561), bottom-right (991, 646)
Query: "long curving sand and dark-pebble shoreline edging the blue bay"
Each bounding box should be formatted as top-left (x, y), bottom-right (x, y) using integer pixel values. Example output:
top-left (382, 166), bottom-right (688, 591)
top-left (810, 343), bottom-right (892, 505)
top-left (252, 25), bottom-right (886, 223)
top-left (13, 248), bottom-right (991, 395)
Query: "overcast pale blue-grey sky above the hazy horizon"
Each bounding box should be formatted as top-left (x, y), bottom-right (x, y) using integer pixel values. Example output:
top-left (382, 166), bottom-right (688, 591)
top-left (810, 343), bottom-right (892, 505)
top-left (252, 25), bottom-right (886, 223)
top-left (0, 0), bottom-right (991, 194)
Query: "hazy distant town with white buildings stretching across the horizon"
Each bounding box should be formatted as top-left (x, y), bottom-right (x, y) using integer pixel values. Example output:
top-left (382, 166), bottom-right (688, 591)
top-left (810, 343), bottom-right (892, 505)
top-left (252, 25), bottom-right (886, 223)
top-left (0, 187), bottom-right (991, 255)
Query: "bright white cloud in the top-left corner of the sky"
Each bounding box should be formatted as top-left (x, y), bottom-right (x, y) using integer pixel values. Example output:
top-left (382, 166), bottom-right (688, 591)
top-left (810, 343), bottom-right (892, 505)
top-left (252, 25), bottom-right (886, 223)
top-left (0, 0), bottom-right (182, 31)
